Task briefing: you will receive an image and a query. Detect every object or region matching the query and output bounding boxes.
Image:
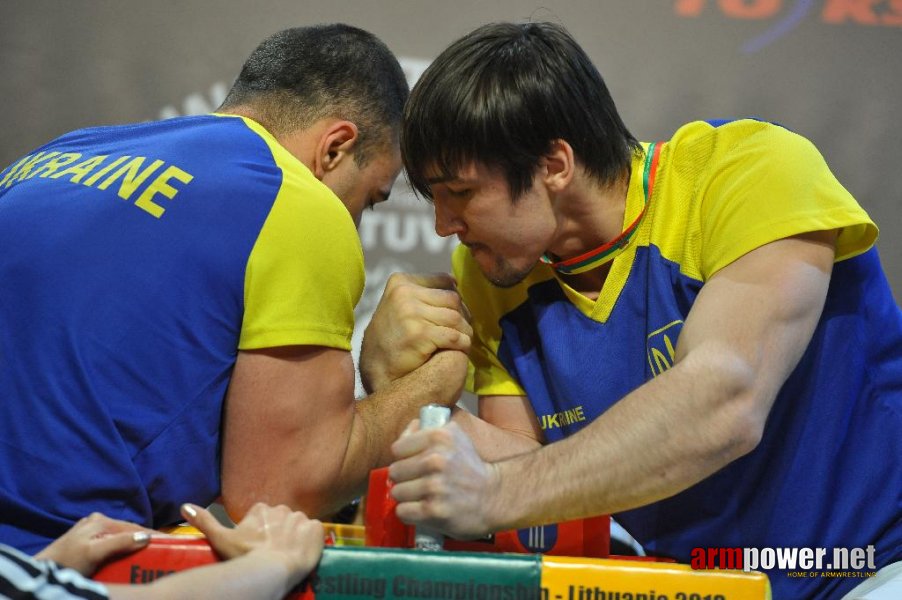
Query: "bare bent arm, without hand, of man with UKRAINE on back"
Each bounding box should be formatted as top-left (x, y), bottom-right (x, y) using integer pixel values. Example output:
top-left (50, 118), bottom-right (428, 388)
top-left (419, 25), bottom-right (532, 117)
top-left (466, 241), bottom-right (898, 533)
top-left (222, 349), bottom-right (467, 520)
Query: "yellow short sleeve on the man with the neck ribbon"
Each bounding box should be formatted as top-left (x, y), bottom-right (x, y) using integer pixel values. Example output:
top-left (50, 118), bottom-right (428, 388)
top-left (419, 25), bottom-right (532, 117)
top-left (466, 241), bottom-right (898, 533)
top-left (677, 121), bottom-right (877, 280)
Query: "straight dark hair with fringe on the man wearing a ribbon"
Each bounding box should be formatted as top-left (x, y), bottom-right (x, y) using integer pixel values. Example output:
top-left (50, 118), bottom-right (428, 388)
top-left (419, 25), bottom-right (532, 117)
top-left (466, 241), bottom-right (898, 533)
top-left (401, 23), bottom-right (641, 199)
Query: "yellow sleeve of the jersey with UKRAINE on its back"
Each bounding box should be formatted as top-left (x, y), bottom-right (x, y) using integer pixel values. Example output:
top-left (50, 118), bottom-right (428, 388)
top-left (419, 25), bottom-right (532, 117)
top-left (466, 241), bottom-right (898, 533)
top-left (238, 120), bottom-right (365, 350)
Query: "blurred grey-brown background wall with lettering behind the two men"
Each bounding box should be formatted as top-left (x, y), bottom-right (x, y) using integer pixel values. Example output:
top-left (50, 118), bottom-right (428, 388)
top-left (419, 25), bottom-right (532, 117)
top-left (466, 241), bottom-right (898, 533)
top-left (0, 0), bottom-right (902, 392)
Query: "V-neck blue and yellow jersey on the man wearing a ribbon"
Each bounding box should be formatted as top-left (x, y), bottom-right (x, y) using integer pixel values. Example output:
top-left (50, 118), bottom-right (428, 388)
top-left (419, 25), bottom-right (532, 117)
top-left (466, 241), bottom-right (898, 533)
top-left (462, 120), bottom-right (902, 597)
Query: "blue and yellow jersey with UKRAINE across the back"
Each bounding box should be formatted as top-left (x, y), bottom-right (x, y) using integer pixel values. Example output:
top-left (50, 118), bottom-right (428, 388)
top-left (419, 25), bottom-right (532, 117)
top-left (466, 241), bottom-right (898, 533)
top-left (0, 115), bottom-right (364, 551)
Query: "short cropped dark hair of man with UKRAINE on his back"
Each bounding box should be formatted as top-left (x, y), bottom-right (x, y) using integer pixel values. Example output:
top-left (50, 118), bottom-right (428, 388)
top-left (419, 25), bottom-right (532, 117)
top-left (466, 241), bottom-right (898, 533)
top-left (220, 24), bottom-right (410, 165)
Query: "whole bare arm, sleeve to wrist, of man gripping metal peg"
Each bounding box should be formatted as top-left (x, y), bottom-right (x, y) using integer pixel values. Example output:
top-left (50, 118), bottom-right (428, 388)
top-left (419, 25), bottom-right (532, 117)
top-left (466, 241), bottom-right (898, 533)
top-left (491, 232), bottom-right (835, 527)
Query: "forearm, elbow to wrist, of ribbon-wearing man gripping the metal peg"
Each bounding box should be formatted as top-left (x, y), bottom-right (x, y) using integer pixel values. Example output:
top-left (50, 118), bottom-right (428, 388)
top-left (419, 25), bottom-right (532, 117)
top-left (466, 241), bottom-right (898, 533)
top-left (486, 350), bottom-right (766, 530)
